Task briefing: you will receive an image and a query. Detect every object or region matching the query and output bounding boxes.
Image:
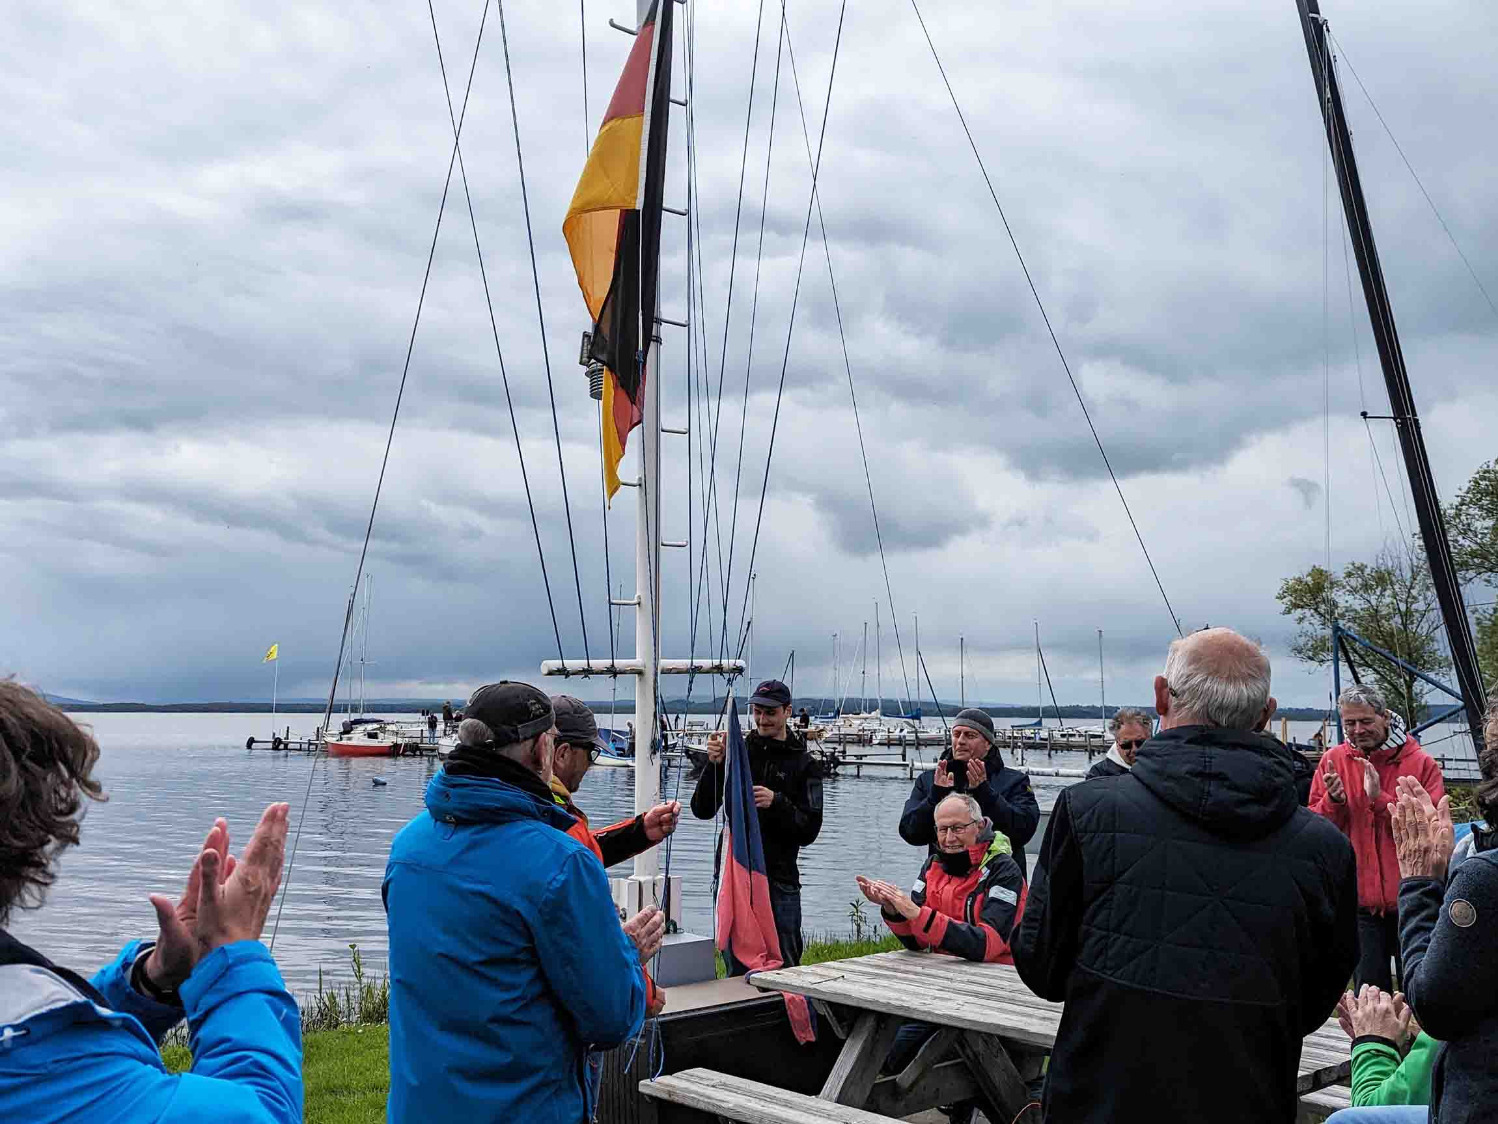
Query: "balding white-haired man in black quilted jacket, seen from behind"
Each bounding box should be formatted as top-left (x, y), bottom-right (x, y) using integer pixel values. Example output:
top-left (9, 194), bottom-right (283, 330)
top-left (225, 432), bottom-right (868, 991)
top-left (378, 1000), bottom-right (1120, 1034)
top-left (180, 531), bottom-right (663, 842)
top-left (1014, 628), bottom-right (1360, 1124)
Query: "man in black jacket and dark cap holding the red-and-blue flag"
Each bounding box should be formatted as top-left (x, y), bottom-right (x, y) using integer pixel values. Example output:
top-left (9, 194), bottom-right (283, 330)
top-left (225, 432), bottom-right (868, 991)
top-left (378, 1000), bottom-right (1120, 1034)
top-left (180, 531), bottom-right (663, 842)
top-left (692, 679), bottom-right (822, 976)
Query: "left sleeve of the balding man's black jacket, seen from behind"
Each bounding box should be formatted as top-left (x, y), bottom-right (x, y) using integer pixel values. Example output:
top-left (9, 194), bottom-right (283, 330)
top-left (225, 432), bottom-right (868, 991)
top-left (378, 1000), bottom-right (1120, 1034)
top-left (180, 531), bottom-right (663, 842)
top-left (1014, 790), bottom-right (1083, 1001)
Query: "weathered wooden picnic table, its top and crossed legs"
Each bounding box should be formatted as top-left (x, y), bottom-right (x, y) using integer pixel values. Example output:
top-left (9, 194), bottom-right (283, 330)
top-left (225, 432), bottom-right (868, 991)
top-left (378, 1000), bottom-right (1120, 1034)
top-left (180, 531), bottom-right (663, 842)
top-left (749, 950), bottom-right (1351, 1121)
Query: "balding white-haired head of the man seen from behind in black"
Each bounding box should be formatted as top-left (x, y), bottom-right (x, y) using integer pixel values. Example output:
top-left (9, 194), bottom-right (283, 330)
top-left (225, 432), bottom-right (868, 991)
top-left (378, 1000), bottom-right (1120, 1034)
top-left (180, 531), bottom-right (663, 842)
top-left (1155, 628), bottom-right (1275, 730)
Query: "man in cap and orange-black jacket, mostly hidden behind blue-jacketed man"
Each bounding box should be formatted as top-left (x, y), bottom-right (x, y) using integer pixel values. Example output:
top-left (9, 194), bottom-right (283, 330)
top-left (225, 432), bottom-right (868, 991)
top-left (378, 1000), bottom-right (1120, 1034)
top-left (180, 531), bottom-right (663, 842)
top-left (551, 695), bottom-right (682, 1015)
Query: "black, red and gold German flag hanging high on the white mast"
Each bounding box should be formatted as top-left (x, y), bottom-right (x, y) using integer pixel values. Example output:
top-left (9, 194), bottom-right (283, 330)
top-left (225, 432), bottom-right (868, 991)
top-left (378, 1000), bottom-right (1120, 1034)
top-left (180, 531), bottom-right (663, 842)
top-left (562, 0), bottom-right (676, 499)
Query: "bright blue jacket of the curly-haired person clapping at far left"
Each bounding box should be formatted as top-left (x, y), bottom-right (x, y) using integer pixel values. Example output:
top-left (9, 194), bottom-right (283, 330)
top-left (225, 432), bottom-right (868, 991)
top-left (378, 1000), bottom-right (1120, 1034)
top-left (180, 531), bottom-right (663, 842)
top-left (0, 934), bottom-right (301, 1124)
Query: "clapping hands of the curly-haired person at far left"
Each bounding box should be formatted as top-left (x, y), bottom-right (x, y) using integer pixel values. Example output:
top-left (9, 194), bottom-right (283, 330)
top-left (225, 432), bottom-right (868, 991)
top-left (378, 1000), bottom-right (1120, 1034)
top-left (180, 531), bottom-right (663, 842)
top-left (141, 803), bottom-right (291, 994)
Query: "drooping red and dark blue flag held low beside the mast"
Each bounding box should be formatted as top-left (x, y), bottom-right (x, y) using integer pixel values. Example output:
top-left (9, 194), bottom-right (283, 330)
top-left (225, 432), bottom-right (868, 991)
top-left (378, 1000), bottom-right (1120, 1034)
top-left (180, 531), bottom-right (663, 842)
top-left (718, 698), bottom-right (816, 1045)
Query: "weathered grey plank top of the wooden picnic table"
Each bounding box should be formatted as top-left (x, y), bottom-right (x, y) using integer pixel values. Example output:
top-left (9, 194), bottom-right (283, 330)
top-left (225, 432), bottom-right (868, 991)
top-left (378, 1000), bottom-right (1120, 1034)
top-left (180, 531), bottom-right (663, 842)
top-left (749, 950), bottom-right (1353, 1093)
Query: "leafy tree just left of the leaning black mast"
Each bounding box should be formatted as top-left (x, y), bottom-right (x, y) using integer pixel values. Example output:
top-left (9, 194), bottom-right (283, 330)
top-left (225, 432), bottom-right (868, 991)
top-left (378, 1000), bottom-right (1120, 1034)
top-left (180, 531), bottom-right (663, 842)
top-left (1275, 547), bottom-right (1452, 721)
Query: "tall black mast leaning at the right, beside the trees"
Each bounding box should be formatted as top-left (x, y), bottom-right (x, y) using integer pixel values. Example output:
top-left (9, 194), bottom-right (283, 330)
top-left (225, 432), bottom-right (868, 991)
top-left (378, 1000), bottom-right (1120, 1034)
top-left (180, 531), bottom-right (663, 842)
top-left (1296, 0), bottom-right (1486, 752)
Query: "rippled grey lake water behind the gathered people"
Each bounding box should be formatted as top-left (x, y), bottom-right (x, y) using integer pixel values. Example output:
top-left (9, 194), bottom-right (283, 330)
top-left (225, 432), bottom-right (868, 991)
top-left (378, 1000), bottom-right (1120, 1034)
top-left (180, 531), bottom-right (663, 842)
top-left (10, 713), bottom-right (1474, 989)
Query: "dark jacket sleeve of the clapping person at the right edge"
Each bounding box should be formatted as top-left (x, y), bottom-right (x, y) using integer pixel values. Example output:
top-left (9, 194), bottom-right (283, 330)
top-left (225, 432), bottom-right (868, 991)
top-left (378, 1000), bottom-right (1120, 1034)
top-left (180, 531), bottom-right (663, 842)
top-left (1399, 857), bottom-right (1498, 1042)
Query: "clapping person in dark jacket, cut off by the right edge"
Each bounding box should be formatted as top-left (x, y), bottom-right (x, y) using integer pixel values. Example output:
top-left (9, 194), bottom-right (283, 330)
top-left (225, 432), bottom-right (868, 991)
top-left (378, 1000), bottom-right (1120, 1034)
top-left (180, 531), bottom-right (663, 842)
top-left (1390, 701), bottom-right (1498, 1124)
